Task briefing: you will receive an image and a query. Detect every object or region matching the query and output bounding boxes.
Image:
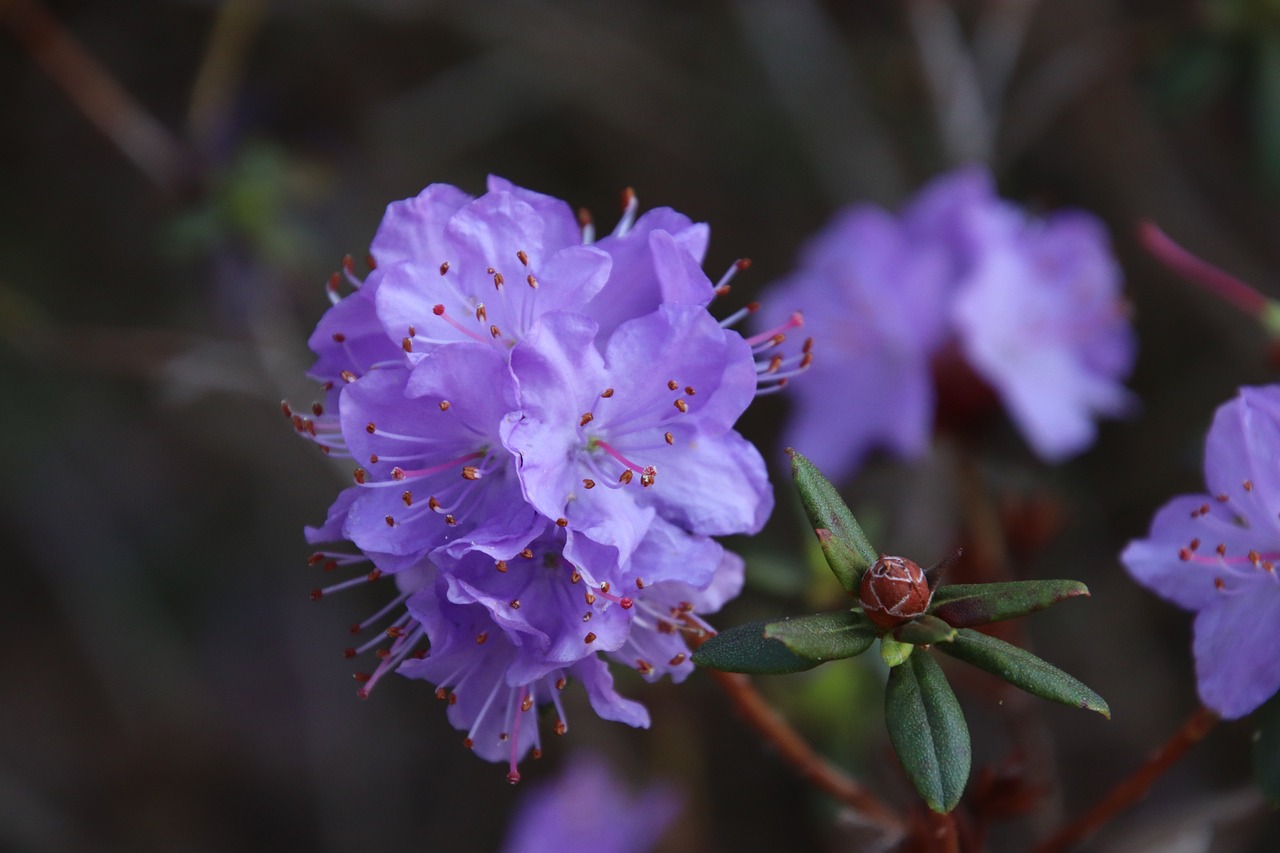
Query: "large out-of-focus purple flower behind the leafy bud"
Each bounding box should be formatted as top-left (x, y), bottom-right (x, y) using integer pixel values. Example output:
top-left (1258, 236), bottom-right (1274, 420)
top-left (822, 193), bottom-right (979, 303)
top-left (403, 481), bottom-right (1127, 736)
top-left (762, 162), bottom-right (1135, 479)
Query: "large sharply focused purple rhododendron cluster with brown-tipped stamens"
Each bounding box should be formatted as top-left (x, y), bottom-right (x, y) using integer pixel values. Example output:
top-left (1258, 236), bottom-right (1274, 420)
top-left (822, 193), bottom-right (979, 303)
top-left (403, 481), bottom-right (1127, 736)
top-left (285, 178), bottom-right (809, 780)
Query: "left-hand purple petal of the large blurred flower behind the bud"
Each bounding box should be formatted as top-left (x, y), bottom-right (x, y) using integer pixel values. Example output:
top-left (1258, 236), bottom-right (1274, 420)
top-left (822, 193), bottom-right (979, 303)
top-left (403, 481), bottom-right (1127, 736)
top-left (758, 206), bottom-right (950, 480)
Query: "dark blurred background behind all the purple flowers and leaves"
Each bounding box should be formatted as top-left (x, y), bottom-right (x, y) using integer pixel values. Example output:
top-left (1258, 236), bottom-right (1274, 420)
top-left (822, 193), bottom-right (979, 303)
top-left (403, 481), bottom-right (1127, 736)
top-left (0, 0), bottom-right (1280, 852)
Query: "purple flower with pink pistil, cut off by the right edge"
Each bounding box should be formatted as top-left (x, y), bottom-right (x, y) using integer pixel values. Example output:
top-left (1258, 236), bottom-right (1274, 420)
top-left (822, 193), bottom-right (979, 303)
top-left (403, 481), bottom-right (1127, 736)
top-left (1120, 386), bottom-right (1280, 720)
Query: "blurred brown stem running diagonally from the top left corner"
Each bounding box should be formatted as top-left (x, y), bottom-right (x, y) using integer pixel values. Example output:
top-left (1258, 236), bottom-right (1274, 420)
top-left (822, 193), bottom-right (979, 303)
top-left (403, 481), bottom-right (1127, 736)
top-left (0, 0), bottom-right (191, 193)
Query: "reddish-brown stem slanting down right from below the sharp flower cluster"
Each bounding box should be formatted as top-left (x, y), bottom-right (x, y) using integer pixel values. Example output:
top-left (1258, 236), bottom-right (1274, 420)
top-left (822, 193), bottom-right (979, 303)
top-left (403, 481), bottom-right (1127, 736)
top-left (709, 670), bottom-right (904, 838)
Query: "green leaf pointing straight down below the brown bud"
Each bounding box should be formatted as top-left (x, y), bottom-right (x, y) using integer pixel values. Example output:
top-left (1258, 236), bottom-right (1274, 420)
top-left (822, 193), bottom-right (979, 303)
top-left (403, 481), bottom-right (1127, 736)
top-left (884, 652), bottom-right (972, 815)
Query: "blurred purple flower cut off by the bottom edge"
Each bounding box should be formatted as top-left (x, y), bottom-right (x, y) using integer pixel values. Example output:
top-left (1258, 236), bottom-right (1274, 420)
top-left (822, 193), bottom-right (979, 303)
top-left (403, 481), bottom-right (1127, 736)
top-left (502, 756), bottom-right (680, 853)
